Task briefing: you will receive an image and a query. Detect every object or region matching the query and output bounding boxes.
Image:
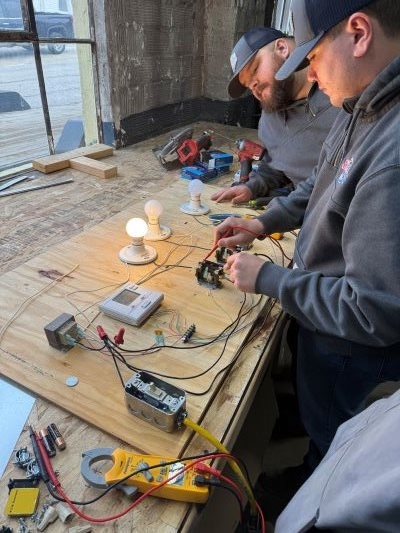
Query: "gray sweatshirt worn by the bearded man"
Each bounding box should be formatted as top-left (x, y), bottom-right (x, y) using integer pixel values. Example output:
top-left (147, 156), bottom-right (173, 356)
top-left (246, 85), bottom-right (339, 198)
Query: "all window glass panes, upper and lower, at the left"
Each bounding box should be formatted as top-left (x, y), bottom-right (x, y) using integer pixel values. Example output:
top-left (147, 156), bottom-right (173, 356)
top-left (0, 0), bottom-right (99, 172)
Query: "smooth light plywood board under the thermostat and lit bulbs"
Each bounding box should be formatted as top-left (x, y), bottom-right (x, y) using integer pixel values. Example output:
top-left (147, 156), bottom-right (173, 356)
top-left (0, 180), bottom-right (290, 455)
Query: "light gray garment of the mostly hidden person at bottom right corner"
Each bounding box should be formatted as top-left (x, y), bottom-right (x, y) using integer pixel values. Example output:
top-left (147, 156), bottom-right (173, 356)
top-left (275, 384), bottom-right (400, 533)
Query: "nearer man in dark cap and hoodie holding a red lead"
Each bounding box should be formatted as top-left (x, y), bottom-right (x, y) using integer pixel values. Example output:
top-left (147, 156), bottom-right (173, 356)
top-left (216, 0), bottom-right (400, 531)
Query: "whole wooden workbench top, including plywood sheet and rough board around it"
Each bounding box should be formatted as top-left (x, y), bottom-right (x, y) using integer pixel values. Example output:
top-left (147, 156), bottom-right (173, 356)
top-left (0, 124), bottom-right (292, 532)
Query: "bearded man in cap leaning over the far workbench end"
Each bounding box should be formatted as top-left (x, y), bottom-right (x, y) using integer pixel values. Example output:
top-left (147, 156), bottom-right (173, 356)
top-left (211, 28), bottom-right (337, 203)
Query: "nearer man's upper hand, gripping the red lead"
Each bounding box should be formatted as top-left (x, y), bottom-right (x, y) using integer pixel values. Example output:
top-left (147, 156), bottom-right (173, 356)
top-left (214, 217), bottom-right (264, 250)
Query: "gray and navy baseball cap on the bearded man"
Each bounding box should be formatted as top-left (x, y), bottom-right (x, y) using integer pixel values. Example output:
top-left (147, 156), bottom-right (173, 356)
top-left (228, 28), bottom-right (286, 98)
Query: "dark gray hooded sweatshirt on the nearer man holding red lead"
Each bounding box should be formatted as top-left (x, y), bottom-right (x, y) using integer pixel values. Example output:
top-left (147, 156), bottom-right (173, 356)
top-left (256, 58), bottom-right (400, 346)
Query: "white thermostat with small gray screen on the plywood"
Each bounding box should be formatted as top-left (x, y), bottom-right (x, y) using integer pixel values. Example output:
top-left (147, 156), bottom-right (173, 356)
top-left (99, 283), bottom-right (164, 326)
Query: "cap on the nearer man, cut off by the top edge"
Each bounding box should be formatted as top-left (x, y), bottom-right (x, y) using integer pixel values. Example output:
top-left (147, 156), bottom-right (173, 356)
top-left (275, 0), bottom-right (374, 80)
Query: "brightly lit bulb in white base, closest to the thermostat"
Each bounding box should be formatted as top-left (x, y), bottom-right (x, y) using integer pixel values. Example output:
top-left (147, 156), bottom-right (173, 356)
top-left (119, 218), bottom-right (157, 265)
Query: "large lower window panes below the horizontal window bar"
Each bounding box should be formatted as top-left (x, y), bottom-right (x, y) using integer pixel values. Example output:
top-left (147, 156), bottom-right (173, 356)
top-left (0, 43), bottom-right (98, 171)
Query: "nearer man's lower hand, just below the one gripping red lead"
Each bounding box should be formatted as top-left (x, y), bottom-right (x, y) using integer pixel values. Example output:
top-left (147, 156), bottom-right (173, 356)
top-left (224, 252), bottom-right (265, 292)
